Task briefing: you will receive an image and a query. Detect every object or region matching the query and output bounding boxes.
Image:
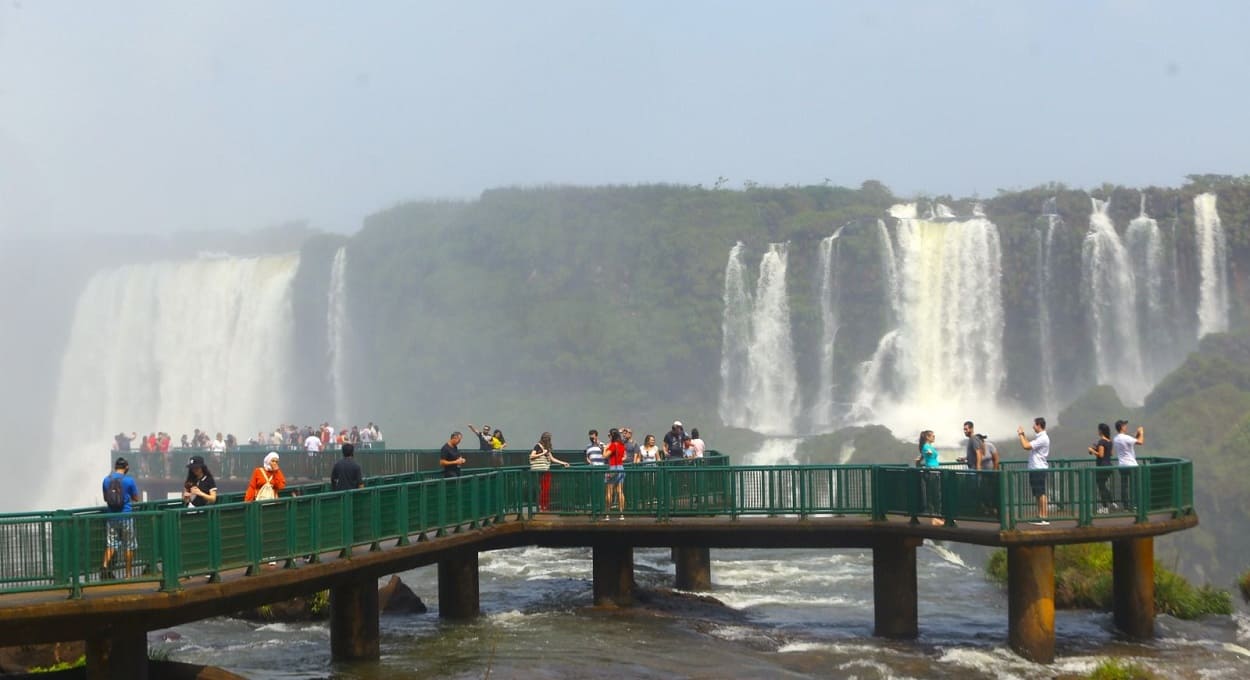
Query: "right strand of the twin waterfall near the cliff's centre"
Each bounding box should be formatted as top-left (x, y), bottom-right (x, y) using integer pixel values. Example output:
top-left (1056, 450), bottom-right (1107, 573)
top-left (746, 244), bottom-right (799, 434)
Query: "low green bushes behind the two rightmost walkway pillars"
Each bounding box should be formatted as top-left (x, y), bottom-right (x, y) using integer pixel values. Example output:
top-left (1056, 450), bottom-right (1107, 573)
top-left (986, 543), bottom-right (1233, 619)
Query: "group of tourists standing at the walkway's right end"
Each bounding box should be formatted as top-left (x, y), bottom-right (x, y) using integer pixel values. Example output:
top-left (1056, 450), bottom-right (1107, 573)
top-left (915, 416), bottom-right (1146, 526)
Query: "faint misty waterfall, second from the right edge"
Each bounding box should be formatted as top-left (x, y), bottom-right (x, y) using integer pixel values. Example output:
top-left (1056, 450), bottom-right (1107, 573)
top-left (1124, 195), bottom-right (1176, 385)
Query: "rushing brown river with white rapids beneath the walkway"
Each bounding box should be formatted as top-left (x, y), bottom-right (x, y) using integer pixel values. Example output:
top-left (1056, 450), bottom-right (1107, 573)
top-left (151, 541), bottom-right (1250, 680)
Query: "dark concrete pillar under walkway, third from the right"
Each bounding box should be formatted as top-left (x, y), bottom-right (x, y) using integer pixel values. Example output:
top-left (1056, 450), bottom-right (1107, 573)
top-left (873, 539), bottom-right (919, 639)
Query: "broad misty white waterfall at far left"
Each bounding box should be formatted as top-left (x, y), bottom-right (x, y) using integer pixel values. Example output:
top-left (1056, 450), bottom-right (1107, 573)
top-left (43, 254), bottom-right (299, 508)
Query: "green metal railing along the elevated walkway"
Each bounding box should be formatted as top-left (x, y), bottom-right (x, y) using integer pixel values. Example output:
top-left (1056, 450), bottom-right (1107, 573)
top-left (0, 455), bottom-right (1194, 596)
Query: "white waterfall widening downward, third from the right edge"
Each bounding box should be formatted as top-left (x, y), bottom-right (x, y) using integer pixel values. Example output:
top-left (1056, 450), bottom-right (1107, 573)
top-left (1081, 199), bottom-right (1150, 404)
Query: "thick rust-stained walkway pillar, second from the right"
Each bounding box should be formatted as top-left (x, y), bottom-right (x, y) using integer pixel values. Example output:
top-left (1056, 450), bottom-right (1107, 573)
top-left (1008, 545), bottom-right (1055, 664)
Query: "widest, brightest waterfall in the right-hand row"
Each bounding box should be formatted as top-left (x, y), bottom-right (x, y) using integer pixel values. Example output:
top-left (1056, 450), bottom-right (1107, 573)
top-left (856, 204), bottom-right (1006, 430)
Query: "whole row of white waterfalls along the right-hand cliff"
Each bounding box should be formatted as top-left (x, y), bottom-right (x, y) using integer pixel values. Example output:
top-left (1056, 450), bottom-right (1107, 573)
top-left (719, 194), bottom-right (1229, 435)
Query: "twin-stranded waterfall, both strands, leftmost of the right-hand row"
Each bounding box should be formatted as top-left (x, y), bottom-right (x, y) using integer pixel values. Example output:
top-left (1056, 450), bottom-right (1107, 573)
top-left (720, 244), bottom-right (799, 434)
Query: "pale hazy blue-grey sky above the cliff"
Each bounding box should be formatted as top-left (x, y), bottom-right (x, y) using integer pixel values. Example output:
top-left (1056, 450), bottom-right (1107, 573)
top-left (0, 0), bottom-right (1250, 231)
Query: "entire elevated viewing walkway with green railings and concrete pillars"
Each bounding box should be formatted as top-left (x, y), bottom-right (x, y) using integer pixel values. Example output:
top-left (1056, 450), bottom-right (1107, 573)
top-left (0, 451), bottom-right (1198, 678)
